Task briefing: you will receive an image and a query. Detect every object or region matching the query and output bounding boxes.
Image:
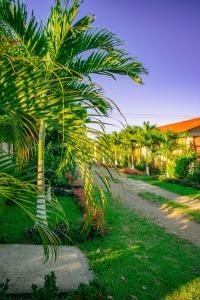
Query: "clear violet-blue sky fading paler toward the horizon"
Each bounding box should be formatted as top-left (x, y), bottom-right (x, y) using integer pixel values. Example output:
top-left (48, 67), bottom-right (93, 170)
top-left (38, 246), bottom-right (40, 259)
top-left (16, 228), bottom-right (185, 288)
top-left (25, 0), bottom-right (200, 130)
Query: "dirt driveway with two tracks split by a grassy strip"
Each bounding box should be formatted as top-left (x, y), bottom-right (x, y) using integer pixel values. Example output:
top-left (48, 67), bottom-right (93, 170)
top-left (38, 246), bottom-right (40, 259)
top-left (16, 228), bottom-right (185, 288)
top-left (95, 171), bottom-right (200, 246)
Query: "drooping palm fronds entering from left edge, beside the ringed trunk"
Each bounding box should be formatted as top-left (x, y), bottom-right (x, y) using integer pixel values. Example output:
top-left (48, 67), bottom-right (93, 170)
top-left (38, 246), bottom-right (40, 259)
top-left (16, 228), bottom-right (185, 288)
top-left (0, 40), bottom-right (72, 258)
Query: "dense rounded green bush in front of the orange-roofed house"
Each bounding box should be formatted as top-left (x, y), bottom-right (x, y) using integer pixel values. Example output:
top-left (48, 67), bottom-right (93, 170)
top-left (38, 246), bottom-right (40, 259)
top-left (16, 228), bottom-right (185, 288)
top-left (174, 153), bottom-right (196, 179)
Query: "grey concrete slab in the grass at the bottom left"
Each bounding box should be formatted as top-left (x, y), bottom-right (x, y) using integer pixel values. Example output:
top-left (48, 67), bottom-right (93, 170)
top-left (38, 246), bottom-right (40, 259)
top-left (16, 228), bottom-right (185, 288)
top-left (0, 245), bottom-right (93, 294)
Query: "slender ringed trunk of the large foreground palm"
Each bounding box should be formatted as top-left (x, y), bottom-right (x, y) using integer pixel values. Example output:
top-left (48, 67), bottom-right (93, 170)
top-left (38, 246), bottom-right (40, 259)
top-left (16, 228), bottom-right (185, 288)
top-left (37, 120), bottom-right (47, 225)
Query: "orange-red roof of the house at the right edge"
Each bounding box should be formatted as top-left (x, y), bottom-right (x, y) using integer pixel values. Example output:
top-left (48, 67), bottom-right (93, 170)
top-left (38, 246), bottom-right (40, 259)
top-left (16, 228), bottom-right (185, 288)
top-left (160, 118), bottom-right (200, 132)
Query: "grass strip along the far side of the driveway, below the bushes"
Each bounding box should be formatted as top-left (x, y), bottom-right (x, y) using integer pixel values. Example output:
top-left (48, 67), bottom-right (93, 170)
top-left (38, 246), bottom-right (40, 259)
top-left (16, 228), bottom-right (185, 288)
top-left (128, 175), bottom-right (200, 199)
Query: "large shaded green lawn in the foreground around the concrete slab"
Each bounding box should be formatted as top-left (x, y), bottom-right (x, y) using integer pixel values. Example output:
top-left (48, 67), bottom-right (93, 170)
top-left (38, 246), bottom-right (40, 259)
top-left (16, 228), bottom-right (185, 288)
top-left (0, 197), bottom-right (200, 300)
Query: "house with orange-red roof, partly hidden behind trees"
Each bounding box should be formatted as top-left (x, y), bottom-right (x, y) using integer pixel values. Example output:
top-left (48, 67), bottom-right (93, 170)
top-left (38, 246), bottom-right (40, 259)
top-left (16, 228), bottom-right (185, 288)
top-left (160, 118), bottom-right (200, 153)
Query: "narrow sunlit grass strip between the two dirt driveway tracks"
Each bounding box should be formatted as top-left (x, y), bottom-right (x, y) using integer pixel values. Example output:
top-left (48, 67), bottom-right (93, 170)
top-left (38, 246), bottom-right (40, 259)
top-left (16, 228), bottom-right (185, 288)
top-left (138, 192), bottom-right (200, 223)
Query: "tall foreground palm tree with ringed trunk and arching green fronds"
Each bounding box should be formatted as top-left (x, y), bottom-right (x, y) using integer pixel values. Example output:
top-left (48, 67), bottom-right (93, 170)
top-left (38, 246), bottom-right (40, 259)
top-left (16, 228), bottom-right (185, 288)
top-left (0, 0), bottom-right (146, 231)
